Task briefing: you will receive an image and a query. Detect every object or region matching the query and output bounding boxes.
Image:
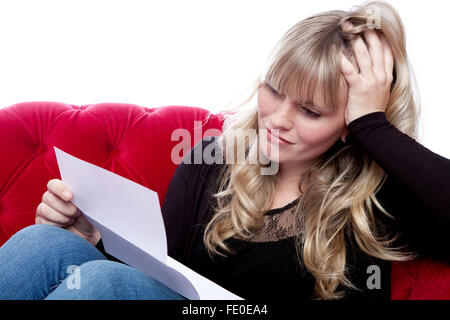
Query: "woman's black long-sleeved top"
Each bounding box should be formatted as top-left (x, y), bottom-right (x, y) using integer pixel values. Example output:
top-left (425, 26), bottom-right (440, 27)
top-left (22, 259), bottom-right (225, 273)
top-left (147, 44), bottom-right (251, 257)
top-left (97, 112), bottom-right (450, 300)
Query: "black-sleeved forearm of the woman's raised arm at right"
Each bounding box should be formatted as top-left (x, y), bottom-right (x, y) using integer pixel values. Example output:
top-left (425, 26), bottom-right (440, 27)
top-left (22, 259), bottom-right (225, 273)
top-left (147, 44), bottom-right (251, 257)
top-left (348, 112), bottom-right (450, 218)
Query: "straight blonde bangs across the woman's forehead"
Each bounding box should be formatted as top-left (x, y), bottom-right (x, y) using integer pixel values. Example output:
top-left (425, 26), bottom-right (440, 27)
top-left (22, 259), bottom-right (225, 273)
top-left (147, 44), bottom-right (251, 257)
top-left (263, 37), bottom-right (341, 110)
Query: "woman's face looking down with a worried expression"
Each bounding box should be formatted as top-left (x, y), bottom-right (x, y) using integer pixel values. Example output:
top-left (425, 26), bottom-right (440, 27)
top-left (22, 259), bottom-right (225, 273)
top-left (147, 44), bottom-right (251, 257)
top-left (257, 80), bottom-right (347, 167)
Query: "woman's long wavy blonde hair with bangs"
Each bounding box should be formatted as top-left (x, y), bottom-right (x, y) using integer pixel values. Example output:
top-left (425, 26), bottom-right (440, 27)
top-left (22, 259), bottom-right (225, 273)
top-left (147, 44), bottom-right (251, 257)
top-left (203, 1), bottom-right (419, 299)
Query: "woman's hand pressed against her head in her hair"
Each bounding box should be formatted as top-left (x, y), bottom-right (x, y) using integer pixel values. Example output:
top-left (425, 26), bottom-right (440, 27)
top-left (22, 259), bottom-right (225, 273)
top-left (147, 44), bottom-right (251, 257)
top-left (340, 22), bottom-right (394, 125)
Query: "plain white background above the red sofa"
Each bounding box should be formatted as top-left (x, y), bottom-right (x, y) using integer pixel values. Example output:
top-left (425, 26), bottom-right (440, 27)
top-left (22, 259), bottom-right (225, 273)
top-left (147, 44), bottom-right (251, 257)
top-left (0, 0), bottom-right (450, 158)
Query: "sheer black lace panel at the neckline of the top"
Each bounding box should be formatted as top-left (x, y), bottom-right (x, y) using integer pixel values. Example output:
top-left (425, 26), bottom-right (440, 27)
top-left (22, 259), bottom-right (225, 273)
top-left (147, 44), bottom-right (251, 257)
top-left (235, 198), bottom-right (303, 242)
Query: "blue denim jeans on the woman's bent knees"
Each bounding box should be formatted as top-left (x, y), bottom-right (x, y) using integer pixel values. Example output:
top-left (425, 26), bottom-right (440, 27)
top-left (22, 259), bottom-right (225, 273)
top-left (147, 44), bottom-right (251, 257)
top-left (0, 224), bottom-right (186, 300)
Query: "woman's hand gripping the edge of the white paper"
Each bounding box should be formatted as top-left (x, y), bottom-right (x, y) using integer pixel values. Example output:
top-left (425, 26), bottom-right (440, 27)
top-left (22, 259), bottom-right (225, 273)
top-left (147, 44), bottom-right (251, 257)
top-left (35, 179), bottom-right (101, 246)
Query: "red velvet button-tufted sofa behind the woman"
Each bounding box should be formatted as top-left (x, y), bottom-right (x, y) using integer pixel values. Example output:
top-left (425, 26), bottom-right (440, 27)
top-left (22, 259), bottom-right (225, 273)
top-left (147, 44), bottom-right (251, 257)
top-left (0, 102), bottom-right (450, 300)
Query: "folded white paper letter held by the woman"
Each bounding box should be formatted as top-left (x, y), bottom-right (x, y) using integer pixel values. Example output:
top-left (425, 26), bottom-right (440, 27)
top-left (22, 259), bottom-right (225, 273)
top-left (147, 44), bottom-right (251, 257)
top-left (54, 147), bottom-right (242, 300)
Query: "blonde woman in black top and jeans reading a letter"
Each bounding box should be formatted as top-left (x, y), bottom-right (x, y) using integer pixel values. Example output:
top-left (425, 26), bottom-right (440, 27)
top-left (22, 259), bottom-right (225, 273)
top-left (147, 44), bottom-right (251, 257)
top-left (0, 2), bottom-right (450, 300)
